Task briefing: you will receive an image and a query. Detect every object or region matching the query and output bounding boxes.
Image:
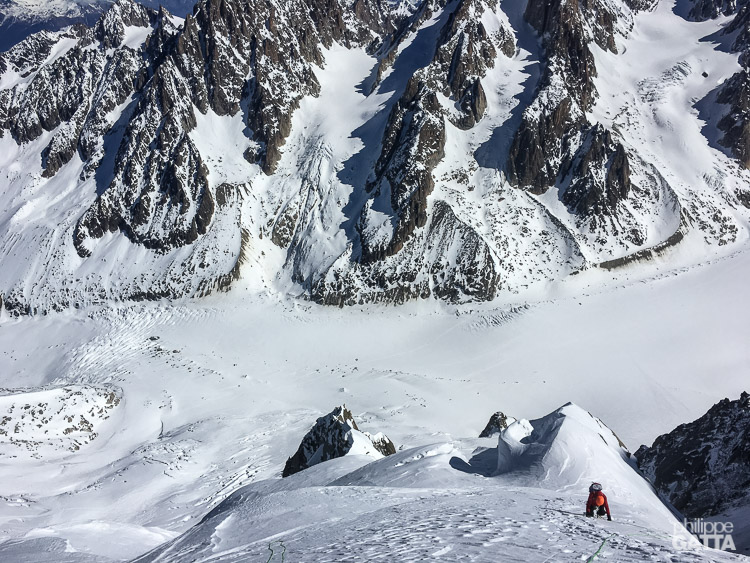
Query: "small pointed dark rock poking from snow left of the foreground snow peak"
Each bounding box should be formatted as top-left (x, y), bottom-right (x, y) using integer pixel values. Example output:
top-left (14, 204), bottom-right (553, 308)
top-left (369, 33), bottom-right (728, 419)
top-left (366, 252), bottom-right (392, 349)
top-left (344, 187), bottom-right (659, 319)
top-left (281, 405), bottom-right (396, 477)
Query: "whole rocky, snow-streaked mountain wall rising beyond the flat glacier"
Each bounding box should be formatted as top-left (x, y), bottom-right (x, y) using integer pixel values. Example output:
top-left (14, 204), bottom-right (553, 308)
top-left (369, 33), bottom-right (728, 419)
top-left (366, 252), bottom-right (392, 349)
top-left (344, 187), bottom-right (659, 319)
top-left (0, 0), bottom-right (750, 312)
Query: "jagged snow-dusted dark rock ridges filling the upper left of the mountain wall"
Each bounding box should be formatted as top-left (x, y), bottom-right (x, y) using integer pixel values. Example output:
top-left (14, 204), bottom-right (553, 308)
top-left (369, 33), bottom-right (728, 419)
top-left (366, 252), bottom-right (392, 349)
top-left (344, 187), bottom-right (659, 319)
top-left (0, 0), bottom-right (406, 257)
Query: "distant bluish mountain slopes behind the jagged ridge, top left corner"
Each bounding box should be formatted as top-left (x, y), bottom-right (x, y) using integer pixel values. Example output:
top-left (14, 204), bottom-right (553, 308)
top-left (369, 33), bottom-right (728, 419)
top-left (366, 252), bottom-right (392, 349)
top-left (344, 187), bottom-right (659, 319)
top-left (0, 0), bottom-right (195, 51)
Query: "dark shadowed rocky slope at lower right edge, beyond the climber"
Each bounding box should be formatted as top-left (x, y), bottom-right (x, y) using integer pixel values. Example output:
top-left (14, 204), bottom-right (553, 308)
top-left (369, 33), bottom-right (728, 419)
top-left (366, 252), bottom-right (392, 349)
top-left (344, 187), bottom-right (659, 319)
top-left (636, 393), bottom-right (750, 553)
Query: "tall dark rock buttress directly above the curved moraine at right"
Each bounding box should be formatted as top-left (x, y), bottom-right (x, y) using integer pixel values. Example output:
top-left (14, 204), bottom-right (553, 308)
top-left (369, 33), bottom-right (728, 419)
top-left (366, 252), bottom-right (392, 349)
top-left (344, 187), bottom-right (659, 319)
top-left (506, 0), bottom-right (679, 256)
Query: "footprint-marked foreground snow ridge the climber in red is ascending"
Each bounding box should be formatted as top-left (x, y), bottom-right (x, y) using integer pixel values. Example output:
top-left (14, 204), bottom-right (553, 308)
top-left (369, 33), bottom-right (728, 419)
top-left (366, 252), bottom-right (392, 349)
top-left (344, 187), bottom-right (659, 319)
top-left (136, 404), bottom-right (740, 562)
